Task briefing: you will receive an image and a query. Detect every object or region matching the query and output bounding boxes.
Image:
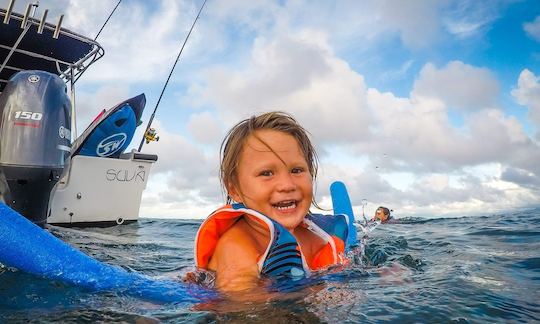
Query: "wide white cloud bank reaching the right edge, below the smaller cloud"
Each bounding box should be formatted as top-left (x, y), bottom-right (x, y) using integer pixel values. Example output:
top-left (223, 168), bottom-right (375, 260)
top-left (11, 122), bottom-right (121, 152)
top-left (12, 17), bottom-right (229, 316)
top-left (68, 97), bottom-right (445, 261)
top-left (362, 84), bottom-right (540, 173)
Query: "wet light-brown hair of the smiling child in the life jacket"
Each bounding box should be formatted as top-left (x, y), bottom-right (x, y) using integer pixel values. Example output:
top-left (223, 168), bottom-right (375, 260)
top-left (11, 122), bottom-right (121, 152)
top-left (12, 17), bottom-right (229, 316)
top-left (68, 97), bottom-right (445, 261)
top-left (220, 111), bottom-right (318, 206)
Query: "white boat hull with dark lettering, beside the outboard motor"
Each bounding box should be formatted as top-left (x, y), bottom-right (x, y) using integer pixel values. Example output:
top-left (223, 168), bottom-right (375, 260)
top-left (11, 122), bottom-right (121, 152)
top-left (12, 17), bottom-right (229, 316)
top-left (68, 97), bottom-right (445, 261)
top-left (47, 152), bottom-right (157, 225)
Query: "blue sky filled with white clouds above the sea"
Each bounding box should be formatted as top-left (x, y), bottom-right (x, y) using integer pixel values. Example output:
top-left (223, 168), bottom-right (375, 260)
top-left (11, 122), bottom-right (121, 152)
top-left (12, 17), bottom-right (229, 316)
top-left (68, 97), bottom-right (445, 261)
top-left (12, 0), bottom-right (540, 218)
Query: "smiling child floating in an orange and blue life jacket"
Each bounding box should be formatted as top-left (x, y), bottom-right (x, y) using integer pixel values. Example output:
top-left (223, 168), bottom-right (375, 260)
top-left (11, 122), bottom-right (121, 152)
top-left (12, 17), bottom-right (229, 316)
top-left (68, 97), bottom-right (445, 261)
top-left (195, 112), bottom-right (348, 291)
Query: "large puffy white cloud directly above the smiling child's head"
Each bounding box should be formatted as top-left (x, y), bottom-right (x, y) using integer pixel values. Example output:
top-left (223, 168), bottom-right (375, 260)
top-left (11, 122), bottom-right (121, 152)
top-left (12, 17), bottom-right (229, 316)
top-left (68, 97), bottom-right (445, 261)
top-left (201, 32), bottom-right (369, 141)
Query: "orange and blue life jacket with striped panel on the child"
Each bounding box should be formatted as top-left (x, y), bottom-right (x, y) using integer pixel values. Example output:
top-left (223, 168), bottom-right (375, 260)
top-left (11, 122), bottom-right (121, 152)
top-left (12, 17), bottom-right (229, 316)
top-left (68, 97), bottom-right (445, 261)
top-left (195, 204), bottom-right (350, 277)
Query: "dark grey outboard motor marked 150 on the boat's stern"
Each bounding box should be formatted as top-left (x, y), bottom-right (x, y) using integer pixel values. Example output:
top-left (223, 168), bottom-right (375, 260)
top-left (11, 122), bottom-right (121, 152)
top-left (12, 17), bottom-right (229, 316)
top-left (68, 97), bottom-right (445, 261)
top-left (0, 71), bottom-right (71, 226)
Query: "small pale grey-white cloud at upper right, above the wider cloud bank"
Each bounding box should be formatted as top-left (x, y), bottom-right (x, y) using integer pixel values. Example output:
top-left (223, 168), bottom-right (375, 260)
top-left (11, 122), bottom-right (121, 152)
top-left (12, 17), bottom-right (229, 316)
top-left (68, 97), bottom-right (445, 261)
top-left (413, 61), bottom-right (499, 111)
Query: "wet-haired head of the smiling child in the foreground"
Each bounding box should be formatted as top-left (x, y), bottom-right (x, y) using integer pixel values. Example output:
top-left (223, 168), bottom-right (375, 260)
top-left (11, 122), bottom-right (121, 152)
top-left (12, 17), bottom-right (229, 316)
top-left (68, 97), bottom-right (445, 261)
top-left (220, 111), bottom-right (317, 230)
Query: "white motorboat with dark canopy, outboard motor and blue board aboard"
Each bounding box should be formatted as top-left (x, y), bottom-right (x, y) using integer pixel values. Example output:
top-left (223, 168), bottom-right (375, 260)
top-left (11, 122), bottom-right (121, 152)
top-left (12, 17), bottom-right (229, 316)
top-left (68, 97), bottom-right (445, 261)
top-left (0, 0), bottom-right (157, 226)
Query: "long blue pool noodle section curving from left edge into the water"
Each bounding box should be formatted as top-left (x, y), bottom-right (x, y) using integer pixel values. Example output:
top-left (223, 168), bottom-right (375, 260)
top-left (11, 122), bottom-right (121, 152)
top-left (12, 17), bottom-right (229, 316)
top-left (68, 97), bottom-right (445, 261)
top-left (0, 203), bottom-right (217, 302)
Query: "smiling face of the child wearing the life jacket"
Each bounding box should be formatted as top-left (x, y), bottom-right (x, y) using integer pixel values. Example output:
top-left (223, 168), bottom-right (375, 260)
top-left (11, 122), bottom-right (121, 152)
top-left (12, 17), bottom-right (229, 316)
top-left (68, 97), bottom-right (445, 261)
top-left (228, 129), bottom-right (313, 231)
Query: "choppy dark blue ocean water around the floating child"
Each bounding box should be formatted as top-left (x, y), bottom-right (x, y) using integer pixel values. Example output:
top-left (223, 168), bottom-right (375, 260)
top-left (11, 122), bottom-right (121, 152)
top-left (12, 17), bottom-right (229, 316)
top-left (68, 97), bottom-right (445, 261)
top-left (0, 209), bottom-right (540, 323)
